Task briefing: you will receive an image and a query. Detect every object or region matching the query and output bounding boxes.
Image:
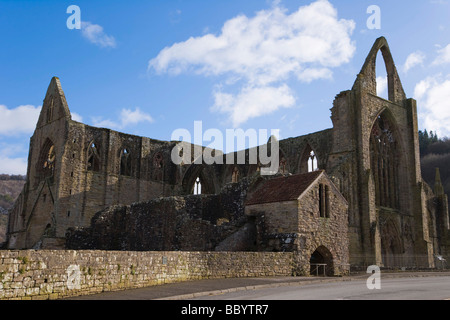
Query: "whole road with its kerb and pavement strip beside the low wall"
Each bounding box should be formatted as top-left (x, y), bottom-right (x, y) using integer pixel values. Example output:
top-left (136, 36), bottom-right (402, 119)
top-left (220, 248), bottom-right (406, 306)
top-left (65, 272), bottom-right (450, 300)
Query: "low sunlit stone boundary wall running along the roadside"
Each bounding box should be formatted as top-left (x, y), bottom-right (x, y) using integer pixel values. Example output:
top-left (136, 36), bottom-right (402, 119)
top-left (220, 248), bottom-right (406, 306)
top-left (0, 250), bottom-right (295, 300)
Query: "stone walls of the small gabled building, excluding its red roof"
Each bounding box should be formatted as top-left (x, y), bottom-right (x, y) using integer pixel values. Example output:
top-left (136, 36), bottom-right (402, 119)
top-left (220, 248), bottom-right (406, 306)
top-left (246, 175), bottom-right (349, 275)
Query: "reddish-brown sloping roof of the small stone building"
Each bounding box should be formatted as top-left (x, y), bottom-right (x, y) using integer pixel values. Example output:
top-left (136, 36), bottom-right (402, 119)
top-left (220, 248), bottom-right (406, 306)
top-left (245, 170), bottom-right (323, 206)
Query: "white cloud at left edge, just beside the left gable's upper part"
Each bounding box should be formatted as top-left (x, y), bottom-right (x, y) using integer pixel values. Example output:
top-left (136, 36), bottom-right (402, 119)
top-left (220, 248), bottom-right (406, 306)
top-left (0, 105), bottom-right (41, 136)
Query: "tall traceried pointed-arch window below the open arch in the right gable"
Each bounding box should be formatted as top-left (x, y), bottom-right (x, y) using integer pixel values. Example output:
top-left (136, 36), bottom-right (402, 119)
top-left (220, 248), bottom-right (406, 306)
top-left (370, 115), bottom-right (398, 209)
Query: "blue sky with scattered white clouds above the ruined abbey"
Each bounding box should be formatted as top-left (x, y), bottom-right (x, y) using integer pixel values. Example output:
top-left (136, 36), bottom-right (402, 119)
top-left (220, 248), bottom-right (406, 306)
top-left (0, 0), bottom-right (450, 174)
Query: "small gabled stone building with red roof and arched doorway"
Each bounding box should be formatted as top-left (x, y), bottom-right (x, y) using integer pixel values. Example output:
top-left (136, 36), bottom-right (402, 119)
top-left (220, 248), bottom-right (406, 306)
top-left (245, 170), bottom-right (349, 274)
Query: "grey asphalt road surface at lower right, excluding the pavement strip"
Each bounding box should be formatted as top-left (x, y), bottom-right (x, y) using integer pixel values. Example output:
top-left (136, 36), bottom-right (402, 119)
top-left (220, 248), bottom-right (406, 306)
top-left (192, 276), bottom-right (450, 300)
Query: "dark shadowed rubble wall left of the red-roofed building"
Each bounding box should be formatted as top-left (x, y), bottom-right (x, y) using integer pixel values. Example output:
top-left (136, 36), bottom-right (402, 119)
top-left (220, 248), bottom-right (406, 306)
top-left (66, 179), bottom-right (256, 251)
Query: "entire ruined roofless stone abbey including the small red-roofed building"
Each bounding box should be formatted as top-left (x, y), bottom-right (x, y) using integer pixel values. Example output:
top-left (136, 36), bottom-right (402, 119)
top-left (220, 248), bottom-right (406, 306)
top-left (7, 38), bottom-right (450, 274)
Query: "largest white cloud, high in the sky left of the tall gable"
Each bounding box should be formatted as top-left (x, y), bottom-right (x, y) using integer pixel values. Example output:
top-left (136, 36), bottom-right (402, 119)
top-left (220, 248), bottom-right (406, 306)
top-left (149, 0), bottom-right (355, 123)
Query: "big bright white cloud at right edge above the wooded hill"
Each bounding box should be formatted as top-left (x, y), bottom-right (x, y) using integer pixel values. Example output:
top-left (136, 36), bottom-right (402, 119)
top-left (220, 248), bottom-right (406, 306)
top-left (414, 75), bottom-right (450, 137)
